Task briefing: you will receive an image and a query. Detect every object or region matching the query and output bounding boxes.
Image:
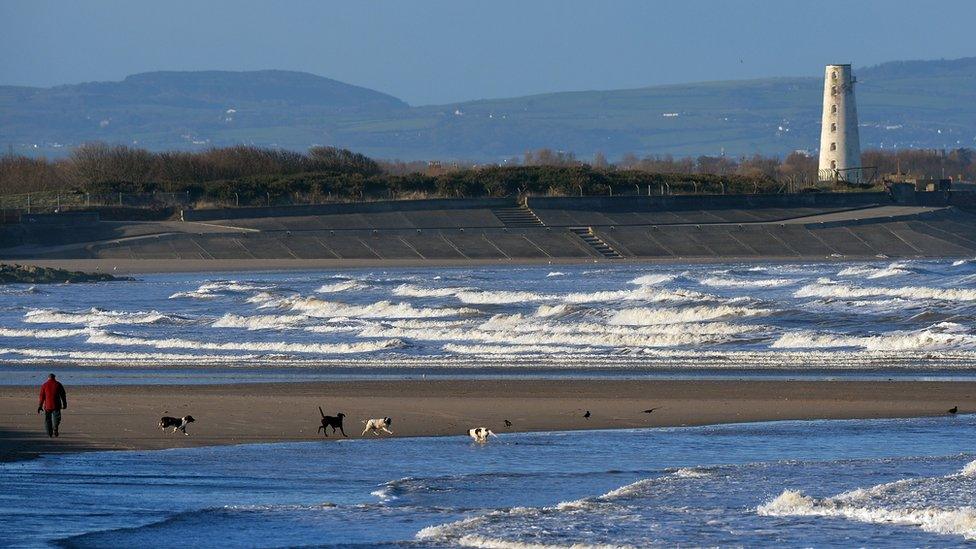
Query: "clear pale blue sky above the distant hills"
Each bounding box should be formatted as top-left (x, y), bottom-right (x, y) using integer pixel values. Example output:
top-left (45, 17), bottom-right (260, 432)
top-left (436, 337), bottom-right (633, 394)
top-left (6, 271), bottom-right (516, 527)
top-left (0, 0), bottom-right (976, 105)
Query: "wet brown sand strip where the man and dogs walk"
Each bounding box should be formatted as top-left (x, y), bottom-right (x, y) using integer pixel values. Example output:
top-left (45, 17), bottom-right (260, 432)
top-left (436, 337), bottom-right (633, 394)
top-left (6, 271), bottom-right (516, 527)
top-left (0, 380), bottom-right (976, 461)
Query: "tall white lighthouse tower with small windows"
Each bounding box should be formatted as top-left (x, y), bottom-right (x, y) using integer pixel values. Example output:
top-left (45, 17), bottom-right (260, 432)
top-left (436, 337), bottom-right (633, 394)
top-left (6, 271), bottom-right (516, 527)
top-left (820, 64), bottom-right (862, 183)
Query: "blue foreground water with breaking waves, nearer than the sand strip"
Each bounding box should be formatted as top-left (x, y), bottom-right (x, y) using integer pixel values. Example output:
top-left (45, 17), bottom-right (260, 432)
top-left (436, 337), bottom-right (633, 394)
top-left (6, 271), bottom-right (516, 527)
top-left (0, 416), bottom-right (976, 548)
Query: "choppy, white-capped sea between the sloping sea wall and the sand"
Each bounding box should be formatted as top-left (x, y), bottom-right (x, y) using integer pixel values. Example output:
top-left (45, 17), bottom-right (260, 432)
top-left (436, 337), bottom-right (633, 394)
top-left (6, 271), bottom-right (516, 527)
top-left (0, 260), bottom-right (976, 376)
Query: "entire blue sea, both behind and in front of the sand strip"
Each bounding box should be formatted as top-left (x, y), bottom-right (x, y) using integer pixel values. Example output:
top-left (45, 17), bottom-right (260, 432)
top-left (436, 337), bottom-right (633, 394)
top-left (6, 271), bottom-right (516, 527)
top-left (0, 259), bottom-right (976, 548)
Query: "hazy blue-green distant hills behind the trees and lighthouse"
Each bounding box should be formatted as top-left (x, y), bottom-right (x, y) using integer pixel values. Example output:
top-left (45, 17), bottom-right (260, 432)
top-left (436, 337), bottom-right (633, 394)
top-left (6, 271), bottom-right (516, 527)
top-left (0, 57), bottom-right (976, 161)
